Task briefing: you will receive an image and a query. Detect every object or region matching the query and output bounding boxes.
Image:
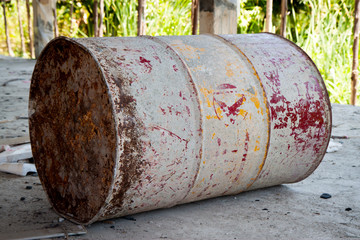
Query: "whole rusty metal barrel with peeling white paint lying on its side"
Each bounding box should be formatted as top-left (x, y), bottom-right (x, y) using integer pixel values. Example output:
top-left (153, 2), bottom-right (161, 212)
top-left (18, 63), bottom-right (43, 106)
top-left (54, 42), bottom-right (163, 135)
top-left (29, 33), bottom-right (331, 224)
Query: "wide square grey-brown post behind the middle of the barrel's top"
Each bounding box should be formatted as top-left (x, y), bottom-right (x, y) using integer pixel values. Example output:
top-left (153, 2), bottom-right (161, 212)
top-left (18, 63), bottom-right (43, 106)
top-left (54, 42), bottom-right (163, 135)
top-left (200, 0), bottom-right (239, 34)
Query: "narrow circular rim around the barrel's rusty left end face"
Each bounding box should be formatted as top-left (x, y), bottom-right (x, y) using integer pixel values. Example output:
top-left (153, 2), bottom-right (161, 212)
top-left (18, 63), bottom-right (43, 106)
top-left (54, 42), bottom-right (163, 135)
top-left (28, 36), bottom-right (119, 225)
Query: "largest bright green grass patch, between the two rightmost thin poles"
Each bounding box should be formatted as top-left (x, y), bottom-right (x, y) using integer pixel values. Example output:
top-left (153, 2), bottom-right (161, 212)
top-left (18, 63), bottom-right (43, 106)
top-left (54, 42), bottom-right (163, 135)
top-left (286, 0), bottom-right (360, 104)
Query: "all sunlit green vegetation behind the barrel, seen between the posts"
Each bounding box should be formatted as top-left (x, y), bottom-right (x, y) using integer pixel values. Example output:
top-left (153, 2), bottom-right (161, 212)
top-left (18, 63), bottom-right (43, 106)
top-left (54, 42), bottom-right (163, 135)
top-left (0, 0), bottom-right (360, 104)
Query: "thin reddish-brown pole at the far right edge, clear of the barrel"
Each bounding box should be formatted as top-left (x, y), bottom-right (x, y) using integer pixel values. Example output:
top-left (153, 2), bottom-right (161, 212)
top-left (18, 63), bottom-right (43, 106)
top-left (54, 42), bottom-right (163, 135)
top-left (350, 0), bottom-right (360, 105)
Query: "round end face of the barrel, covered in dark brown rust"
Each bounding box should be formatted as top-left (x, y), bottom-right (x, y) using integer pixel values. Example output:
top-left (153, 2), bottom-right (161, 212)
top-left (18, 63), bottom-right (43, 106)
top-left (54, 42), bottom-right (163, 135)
top-left (29, 39), bottom-right (116, 223)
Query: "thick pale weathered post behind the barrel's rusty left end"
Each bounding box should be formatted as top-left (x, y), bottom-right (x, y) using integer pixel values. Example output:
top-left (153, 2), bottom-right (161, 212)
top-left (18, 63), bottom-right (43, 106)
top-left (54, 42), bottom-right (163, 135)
top-left (33, 0), bottom-right (56, 57)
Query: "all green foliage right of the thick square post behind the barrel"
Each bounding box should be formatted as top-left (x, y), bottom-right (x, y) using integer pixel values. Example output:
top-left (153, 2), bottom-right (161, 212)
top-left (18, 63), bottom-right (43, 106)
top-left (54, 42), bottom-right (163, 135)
top-left (233, 0), bottom-right (360, 105)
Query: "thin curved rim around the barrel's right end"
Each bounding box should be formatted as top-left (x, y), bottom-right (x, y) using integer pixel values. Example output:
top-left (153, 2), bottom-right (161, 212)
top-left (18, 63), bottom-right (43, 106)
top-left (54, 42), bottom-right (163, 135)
top-left (258, 32), bottom-right (332, 183)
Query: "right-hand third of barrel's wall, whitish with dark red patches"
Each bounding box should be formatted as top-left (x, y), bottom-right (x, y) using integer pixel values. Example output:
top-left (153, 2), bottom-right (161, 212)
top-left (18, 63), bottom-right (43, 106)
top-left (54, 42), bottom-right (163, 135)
top-left (222, 34), bottom-right (331, 189)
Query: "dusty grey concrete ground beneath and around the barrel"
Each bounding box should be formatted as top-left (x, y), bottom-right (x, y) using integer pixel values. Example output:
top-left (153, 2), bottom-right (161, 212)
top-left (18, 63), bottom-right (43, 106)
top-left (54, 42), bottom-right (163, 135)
top-left (0, 57), bottom-right (360, 239)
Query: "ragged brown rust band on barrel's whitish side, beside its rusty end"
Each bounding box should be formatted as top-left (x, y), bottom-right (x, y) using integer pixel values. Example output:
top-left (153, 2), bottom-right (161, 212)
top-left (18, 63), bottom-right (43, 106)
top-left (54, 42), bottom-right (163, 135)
top-left (84, 39), bottom-right (147, 214)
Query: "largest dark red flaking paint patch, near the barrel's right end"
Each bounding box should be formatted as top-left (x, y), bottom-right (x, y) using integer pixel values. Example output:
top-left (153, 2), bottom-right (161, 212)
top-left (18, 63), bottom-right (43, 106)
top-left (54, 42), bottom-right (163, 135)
top-left (264, 69), bottom-right (328, 153)
